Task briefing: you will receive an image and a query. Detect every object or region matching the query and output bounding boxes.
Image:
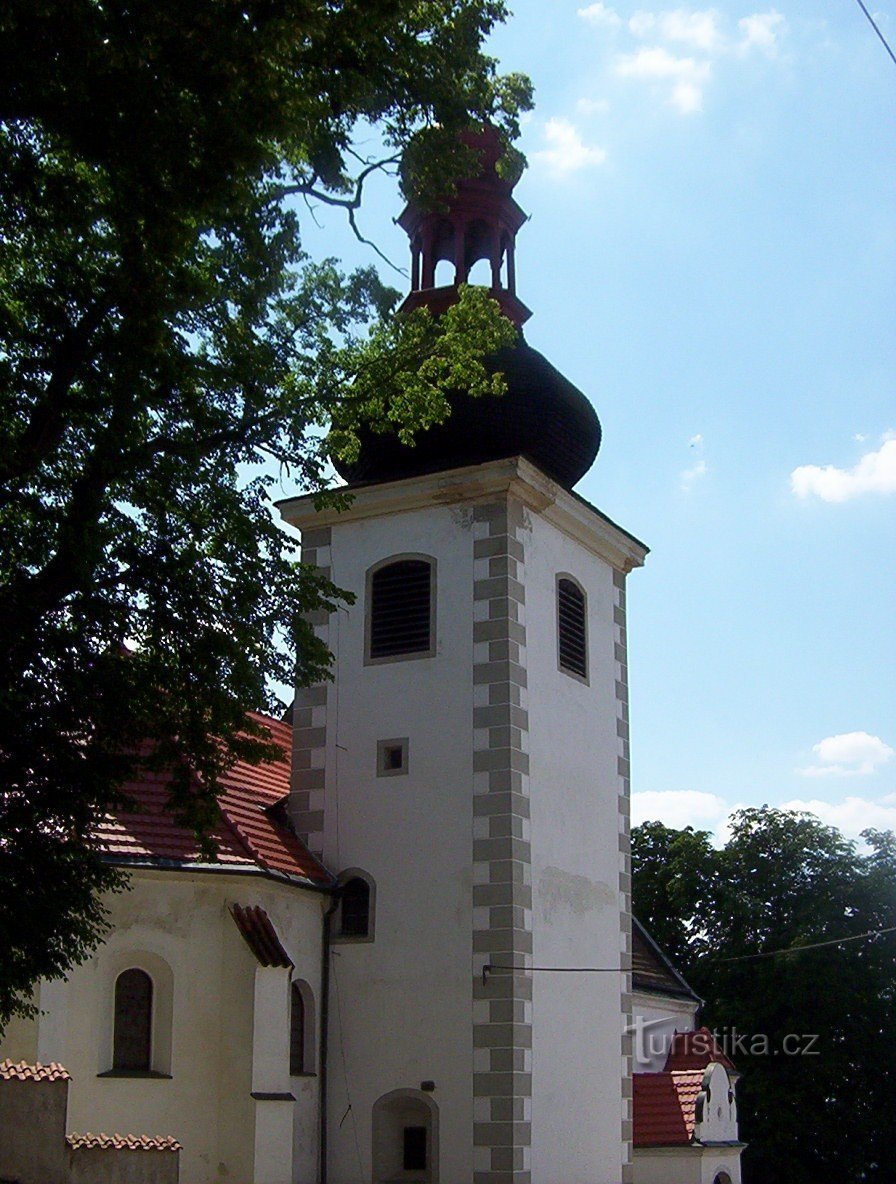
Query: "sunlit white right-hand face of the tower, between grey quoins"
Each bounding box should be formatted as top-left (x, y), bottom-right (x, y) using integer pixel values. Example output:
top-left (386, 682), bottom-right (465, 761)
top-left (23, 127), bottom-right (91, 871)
top-left (526, 515), bottom-right (627, 1184)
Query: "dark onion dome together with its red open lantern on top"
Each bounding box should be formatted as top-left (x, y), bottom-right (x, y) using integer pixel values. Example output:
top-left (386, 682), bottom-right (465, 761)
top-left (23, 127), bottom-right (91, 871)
top-left (334, 126), bottom-right (600, 489)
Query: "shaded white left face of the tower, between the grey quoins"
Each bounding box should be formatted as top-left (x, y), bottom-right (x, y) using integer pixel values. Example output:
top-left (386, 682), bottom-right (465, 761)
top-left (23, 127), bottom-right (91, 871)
top-left (318, 506), bottom-right (472, 1184)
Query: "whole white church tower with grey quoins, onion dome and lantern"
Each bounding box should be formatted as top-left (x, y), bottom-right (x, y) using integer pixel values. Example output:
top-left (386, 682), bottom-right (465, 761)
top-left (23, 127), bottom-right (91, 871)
top-left (275, 129), bottom-right (646, 1184)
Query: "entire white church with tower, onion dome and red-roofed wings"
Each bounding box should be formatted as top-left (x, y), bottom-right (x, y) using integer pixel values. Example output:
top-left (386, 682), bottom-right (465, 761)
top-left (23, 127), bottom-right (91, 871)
top-left (0, 129), bottom-right (742, 1184)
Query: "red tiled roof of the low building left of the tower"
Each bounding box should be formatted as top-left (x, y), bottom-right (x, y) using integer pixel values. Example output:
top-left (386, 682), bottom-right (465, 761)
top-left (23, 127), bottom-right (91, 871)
top-left (98, 713), bottom-right (334, 884)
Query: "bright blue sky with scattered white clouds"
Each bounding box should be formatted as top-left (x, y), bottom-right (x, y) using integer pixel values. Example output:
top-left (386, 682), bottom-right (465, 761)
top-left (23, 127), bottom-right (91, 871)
top-left (295, 0), bottom-right (896, 852)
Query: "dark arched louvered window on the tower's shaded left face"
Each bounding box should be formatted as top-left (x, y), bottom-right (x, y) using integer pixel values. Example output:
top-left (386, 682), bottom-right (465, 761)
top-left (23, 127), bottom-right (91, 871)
top-left (368, 559), bottom-right (433, 661)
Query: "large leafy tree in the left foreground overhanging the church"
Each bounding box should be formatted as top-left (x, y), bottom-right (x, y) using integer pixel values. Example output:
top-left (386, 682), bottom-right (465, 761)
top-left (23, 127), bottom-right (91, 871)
top-left (0, 0), bottom-right (529, 1027)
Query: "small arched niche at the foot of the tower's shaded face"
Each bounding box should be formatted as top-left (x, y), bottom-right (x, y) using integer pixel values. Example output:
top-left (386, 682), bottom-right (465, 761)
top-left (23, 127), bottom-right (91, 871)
top-left (373, 1089), bottom-right (439, 1184)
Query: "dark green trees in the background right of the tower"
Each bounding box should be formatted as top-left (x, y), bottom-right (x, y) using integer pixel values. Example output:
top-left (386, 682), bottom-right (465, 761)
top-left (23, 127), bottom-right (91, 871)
top-left (632, 806), bottom-right (896, 1184)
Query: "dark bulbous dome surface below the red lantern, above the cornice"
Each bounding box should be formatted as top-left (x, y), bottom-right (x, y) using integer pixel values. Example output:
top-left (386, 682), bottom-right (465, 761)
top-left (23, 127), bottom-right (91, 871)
top-left (334, 335), bottom-right (600, 489)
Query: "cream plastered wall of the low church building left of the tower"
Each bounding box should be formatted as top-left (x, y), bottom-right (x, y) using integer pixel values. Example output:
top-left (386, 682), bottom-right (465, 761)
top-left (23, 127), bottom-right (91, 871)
top-left (0, 871), bottom-right (321, 1184)
